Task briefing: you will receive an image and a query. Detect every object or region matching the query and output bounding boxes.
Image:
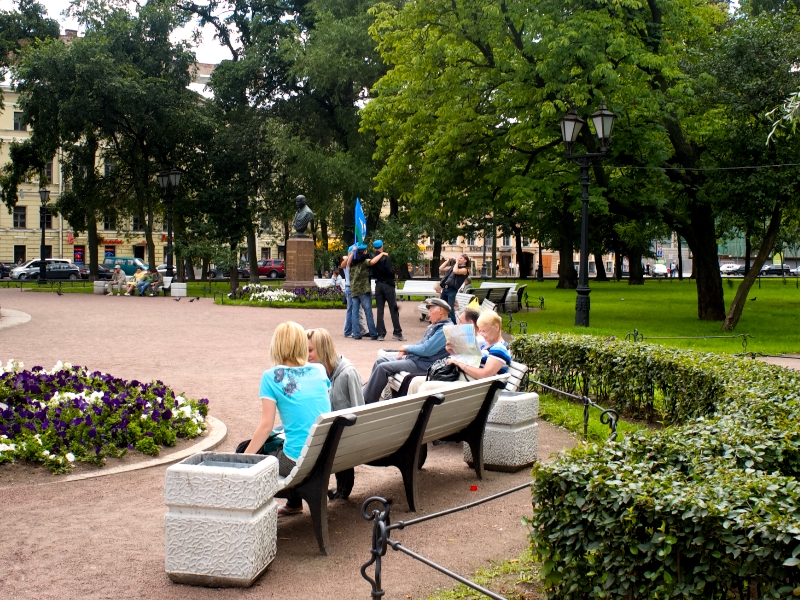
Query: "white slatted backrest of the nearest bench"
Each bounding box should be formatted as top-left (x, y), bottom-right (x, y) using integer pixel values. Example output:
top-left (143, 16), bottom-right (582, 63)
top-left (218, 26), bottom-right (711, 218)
top-left (283, 375), bottom-right (506, 487)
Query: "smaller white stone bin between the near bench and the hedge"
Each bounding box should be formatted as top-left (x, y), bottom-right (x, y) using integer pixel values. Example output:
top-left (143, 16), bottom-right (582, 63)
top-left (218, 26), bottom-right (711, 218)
top-left (464, 392), bottom-right (539, 472)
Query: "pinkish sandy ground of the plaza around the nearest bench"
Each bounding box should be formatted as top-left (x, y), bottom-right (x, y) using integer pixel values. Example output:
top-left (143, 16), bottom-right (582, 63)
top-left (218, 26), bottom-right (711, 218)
top-left (0, 290), bottom-right (575, 600)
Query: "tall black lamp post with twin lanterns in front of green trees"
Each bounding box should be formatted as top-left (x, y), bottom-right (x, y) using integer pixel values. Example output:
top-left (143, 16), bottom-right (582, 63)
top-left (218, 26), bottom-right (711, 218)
top-left (561, 102), bottom-right (616, 327)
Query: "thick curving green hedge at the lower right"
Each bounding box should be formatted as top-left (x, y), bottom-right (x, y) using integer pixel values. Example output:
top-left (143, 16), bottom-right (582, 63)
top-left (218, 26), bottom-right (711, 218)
top-left (512, 334), bottom-right (800, 599)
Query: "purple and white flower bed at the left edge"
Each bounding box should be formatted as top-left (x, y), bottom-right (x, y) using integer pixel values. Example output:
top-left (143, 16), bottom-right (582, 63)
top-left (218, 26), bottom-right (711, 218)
top-left (0, 360), bottom-right (208, 473)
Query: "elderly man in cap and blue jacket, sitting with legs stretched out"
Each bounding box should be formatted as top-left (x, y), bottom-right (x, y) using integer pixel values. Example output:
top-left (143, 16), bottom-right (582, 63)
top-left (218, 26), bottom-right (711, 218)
top-left (364, 298), bottom-right (450, 404)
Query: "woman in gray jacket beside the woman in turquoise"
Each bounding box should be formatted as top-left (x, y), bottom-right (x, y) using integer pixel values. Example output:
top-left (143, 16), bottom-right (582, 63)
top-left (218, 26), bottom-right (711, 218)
top-left (306, 329), bottom-right (364, 500)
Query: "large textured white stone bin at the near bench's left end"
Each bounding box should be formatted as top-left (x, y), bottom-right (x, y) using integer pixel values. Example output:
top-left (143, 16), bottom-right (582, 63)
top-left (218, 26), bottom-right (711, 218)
top-left (164, 452), bottom-right (278, 587)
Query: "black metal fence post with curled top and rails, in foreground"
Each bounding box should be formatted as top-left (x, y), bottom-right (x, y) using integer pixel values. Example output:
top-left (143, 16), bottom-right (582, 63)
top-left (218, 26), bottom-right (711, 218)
top-left (361, 482), bottom-right (531, 600)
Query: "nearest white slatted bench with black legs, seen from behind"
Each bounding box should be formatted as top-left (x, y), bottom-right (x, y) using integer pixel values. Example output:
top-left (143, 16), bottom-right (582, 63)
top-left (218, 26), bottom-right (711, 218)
top-left (275, 375), bottom-right (508, 554)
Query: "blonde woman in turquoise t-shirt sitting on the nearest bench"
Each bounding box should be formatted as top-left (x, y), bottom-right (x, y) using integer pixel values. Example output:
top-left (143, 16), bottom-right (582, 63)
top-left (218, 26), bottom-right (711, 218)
top-left (244, 321), bottom-right (331, 515)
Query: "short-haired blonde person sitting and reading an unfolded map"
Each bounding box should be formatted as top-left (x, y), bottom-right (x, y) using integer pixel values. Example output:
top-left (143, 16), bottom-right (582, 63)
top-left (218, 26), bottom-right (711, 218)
top-left (408, 312), bottom-right (511, 394)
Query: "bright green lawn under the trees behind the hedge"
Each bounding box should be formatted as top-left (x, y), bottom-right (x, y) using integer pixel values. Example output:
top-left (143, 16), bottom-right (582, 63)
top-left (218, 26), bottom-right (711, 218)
top-left (504, 277), bottom-right (800, 354)
